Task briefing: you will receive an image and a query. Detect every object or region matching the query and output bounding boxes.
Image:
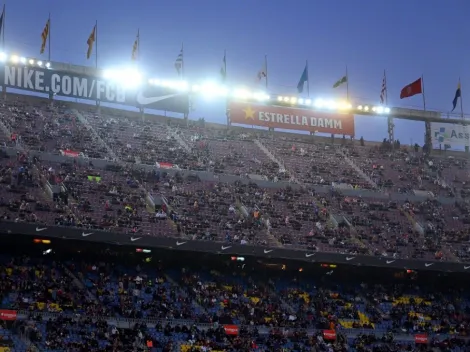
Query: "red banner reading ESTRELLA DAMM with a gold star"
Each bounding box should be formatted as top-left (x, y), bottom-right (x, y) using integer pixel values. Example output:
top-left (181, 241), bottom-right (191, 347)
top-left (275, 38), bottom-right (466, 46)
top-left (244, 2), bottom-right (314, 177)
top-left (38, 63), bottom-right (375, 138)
top-left (228, 101), bottom-right (354, 136)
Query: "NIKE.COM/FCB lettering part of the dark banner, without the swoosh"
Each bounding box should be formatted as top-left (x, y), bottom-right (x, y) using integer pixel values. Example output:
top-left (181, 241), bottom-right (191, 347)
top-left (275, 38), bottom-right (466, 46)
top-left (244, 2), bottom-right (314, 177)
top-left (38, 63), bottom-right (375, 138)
top-left (3, 65), bottom-right (126, 104)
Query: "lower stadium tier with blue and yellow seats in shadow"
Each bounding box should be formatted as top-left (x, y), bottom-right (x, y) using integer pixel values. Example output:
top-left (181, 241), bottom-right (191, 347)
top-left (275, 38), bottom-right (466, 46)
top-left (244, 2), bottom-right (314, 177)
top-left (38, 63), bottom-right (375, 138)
top-left (0, 236), bottom-right (470, 352)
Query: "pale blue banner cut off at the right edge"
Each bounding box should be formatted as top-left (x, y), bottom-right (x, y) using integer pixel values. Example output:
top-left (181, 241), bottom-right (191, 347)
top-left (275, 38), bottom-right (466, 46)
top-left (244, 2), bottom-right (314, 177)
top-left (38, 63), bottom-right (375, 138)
top-left (431, 122), bottom-right (470, 148)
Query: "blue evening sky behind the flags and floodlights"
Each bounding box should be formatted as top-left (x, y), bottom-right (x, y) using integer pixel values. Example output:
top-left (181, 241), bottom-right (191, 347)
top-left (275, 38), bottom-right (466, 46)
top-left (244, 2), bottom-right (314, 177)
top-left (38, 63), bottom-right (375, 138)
top-left (5, 0), bottom-right (470, 143)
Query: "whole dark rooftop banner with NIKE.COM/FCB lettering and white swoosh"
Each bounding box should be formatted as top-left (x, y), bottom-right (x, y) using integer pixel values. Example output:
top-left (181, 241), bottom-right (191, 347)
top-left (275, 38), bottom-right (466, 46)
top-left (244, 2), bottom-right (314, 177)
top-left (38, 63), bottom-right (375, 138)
top-left (0, 64), bottom-right (189, 113)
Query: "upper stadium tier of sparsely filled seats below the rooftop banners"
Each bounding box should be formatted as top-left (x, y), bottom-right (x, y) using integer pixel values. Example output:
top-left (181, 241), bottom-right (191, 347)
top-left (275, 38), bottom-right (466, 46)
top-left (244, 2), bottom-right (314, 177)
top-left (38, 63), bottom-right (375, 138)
top-left (0, 85), bottom-right (470, 271)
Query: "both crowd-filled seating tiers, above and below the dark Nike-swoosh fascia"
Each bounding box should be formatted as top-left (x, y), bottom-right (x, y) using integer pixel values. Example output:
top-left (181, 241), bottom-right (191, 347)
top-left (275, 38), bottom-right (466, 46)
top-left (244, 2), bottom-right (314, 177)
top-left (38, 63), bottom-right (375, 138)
top-left (0, 91), bottom-right (470, 352)
